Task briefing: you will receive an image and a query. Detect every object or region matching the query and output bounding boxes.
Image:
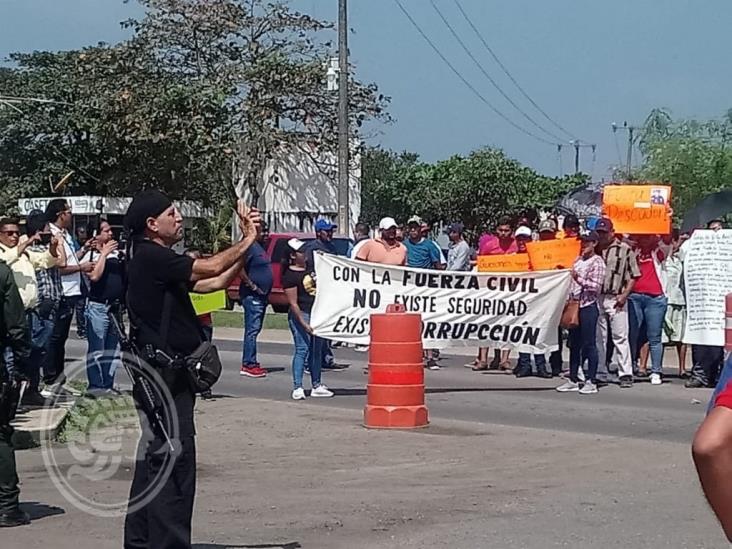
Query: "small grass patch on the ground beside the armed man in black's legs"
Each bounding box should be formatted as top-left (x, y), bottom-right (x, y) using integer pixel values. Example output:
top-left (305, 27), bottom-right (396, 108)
top-left (57, 394), bottom-right (137, 443)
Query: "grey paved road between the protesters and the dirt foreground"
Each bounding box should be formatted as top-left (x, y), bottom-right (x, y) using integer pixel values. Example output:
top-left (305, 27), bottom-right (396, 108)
top-left (64, 334), bottom-right (711, 442)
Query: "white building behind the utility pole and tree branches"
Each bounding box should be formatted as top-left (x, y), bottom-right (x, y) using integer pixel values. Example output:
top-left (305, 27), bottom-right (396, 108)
top-left (233, 141), bottom-right (361, 234)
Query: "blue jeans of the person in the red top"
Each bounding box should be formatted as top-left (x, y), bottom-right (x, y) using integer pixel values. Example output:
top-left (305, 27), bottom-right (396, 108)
top-left (628, 293), bottom-right (668, 374)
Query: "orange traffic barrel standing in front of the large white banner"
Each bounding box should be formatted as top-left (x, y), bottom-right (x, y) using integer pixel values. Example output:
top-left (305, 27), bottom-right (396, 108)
top-left (363, 304), bottom-right (429, 429)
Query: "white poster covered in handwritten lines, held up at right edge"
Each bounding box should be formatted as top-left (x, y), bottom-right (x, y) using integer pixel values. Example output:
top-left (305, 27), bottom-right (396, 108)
top-left (681, 229), bottom-right (732, 347)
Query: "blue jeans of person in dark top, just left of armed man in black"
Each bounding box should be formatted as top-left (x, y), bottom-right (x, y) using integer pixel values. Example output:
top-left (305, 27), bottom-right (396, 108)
top-left (85, 301), bottom-right (119, 389)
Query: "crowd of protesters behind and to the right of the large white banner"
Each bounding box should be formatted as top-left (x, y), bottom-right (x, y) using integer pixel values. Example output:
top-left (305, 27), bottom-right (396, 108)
top-left (351, 210), bottom-right (723, 394)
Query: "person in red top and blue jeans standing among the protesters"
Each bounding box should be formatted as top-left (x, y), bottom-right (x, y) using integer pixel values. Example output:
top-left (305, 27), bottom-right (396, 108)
top-left (628, 235), bottom-right (668, 385)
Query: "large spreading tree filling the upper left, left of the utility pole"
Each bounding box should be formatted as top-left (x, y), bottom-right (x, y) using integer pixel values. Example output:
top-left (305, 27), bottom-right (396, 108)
top-left (0, 0), bottom-right (389, 248)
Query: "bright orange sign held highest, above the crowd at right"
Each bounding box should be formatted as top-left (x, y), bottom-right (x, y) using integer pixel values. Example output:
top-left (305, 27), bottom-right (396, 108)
top-left (602, 185), bottom-right (671, 234)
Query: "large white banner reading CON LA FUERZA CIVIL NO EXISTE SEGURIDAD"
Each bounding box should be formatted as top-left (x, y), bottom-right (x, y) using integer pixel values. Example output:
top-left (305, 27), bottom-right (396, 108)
top-left (310, 253), bottom-right (570, 353)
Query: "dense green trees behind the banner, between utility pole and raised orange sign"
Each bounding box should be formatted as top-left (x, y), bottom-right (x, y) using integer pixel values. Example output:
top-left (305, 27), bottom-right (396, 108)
top-left (361, 149), bottom-right (587, 240)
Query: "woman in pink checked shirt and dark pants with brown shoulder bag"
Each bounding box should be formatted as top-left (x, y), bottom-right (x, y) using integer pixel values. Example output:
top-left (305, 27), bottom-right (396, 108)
top-left (557, 231), bottom-right (606, 395)
